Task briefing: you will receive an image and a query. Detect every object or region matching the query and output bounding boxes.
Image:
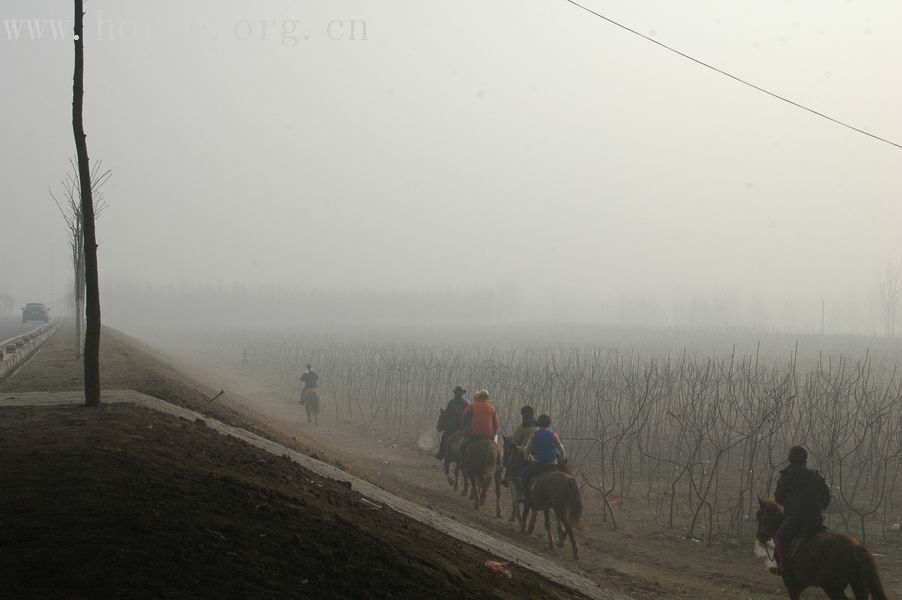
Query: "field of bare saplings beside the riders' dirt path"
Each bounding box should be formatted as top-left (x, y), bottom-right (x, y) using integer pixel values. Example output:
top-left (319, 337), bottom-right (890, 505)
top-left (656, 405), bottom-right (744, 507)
top-left (217, 338), bottom-right (902, 548)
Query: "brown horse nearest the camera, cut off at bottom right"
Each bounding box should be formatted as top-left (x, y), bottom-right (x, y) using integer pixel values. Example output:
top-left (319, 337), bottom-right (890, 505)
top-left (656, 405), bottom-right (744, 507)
top-left (757, 498), bottom-right (886, 600)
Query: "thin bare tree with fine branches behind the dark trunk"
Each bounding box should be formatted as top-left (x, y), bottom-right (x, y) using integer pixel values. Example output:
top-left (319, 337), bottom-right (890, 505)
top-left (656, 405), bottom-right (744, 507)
top-left (50, 159), bottom-right (112, 357)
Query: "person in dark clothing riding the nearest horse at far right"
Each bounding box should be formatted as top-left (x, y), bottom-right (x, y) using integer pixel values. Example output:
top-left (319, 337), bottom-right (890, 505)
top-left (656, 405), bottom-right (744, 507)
top-left (771, 446), bottom-right (830, 575)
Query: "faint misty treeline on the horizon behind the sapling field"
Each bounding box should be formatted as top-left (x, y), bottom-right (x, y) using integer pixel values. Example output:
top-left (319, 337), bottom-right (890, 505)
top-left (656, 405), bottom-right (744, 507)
top-left (104, 270), bottom-right (902, 337)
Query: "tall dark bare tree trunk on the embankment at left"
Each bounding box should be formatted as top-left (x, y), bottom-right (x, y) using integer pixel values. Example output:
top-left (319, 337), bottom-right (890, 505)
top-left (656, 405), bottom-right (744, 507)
top-left (72, 0), bottom-right (100, 406)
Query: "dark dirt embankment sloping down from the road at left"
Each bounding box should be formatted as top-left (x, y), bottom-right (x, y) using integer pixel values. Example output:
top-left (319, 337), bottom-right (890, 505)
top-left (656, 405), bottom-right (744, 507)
top-left (0, 328), bottom-right (588, 599)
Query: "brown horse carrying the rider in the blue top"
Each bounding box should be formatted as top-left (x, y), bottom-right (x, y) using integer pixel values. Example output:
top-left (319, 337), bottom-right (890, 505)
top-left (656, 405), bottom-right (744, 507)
top-left (520, 471), bottom-right (583, 560)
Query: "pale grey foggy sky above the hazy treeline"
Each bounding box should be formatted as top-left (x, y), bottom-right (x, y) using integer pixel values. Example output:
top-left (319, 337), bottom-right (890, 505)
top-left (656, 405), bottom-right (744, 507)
top-left (0, 0), bottom-right (902, 328)
